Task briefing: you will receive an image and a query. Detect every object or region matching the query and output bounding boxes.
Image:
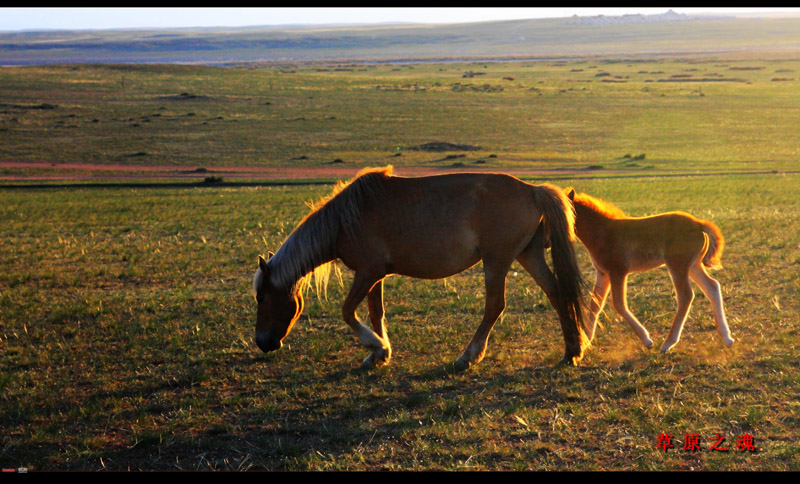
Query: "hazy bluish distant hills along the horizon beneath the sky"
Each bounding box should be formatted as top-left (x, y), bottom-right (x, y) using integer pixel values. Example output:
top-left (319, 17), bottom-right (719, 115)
top-left (0, 11), bottom-right (800, 65)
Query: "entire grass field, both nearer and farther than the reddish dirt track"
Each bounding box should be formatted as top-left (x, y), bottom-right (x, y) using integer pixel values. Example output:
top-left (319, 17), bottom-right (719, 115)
top-left (0, 58), bottom-right (800, 470)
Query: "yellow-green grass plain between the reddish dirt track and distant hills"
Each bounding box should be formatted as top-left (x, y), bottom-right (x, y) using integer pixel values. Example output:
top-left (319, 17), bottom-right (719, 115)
top-left (0, 57), bottom-right (800, 175)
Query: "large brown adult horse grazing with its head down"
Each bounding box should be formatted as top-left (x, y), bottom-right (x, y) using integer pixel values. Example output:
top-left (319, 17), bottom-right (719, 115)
top-left (253, 166), bottom-right (587, 370)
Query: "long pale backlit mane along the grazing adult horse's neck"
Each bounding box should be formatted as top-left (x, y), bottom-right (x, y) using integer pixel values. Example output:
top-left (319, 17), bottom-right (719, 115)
top-left (264, 165), bottom-right (393, 294)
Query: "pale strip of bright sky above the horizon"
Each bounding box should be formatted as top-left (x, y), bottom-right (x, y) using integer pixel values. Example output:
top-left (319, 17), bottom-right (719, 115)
top-left (0, 7), bottom-right (800, 31)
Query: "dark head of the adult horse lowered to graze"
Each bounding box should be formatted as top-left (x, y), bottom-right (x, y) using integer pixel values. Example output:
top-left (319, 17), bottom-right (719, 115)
top-left (253, 253), bottom-right (303, 353)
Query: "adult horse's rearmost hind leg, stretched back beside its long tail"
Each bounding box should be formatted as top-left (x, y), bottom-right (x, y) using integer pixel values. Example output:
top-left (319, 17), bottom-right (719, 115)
top-left (517, 244), bottom-right (583, 365)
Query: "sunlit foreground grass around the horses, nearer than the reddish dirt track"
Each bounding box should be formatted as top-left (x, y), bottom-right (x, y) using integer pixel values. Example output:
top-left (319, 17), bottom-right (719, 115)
top-left (0, 175), bottom-right (800, 470)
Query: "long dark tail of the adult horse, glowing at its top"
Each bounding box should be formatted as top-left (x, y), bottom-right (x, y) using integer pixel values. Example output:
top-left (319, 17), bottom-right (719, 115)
top-left (534, 184), bottom-right (589, 364)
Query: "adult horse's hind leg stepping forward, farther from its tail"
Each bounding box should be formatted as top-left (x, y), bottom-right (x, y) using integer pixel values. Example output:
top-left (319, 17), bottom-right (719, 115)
top-left (455, 260), bottom-right (510, 371)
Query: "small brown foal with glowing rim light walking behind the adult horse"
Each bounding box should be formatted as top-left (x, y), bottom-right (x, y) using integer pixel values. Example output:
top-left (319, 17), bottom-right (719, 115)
top-left (566, 188), bottom-right (734, 353)
